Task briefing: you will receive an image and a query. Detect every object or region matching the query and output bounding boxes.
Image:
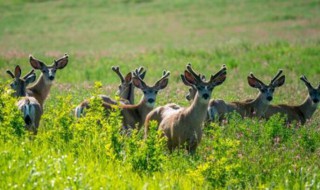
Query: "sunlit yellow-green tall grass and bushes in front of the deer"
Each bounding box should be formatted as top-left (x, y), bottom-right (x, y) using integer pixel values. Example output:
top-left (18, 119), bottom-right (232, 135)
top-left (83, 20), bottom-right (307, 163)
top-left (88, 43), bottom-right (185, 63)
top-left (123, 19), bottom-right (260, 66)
top-left (0, 80), bottom-right (320, 189)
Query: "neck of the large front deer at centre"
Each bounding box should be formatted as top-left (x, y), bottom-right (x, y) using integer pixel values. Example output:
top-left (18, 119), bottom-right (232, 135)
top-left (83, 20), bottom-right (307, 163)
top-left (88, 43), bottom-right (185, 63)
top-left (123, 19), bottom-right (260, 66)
top-left (185, 93), bottom-right (210, 125)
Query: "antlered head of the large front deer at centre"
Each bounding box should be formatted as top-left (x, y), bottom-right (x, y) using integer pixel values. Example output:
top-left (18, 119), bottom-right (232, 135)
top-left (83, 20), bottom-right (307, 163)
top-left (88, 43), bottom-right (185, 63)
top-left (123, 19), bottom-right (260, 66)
top-left (181, 64), bottom-right (227, 101)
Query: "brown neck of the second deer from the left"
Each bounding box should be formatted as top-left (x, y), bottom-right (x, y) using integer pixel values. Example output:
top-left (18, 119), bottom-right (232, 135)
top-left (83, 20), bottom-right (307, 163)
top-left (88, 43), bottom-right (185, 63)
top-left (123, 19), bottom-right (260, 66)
top-left (27, 73), bottom-right (52, 107)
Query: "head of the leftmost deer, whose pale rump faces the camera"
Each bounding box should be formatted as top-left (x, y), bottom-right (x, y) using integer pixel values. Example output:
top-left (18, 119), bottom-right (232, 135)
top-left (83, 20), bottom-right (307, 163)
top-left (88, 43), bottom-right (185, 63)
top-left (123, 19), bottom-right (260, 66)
top-left (7, 65), bottom-right (36, 97)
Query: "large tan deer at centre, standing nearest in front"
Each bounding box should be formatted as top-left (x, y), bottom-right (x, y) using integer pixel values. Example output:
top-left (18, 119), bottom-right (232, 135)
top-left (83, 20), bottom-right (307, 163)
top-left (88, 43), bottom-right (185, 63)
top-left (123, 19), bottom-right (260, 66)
top-left (145, 64), bottom-right (227, 154)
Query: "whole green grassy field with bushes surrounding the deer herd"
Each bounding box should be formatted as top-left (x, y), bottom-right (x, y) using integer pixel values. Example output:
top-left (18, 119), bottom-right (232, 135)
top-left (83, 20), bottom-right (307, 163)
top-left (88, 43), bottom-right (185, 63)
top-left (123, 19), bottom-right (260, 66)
top-left (0, 0), bottom-right (320, 189)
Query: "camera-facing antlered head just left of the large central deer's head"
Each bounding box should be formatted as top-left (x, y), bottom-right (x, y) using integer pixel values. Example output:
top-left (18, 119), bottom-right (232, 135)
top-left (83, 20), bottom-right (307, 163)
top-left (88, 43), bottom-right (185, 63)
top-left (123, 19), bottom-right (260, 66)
top-left (132, 69), bottom-right (170, 107)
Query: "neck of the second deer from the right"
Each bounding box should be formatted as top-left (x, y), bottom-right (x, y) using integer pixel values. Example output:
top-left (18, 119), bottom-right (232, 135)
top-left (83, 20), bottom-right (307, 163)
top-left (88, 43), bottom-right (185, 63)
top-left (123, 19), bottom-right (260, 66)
top-left (249, 93), bottom-right (270, 117)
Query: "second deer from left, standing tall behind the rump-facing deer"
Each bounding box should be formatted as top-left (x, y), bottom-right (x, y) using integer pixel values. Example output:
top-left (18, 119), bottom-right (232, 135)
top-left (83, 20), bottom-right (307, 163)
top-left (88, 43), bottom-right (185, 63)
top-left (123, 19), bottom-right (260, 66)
top-left (26, 54), bottom-right (68, 109)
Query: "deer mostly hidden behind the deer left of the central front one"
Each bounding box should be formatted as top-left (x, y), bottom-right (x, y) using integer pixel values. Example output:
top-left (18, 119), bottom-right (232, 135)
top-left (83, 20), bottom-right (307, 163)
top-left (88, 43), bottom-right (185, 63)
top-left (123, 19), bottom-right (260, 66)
top-left (75, 66), bottom-right (146, 118)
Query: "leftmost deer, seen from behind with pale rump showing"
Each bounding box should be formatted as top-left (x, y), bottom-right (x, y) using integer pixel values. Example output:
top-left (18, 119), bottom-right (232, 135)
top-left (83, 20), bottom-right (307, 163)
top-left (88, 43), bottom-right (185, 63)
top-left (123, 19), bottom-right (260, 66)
top-left (7, 65), bottom-right (42, 134)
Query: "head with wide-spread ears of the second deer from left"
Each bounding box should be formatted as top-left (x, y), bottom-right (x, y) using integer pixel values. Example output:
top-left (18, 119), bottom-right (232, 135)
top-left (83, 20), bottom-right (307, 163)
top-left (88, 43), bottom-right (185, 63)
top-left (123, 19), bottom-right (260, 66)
top-left (29, 54), bottom-right (68, 82)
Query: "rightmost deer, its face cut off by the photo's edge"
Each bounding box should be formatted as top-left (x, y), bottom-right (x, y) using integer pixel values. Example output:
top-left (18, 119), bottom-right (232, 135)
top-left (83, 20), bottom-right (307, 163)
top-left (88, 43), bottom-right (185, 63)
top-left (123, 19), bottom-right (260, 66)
top-left (266, 75), bottom-right (320, 124)
